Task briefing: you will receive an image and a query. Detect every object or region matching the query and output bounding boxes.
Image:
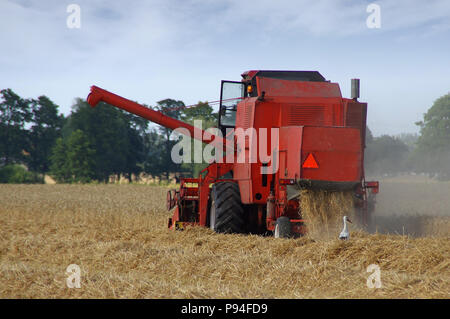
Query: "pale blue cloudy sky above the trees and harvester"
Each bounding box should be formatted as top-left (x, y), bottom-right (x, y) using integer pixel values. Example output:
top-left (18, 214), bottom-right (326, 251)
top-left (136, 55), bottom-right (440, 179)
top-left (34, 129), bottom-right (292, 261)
top-left (0, 0), bottom-right (450, 135)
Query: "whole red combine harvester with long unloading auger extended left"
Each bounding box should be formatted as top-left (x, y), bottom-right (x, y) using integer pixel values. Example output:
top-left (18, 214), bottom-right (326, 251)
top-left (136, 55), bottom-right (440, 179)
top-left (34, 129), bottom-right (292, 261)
top-left (87, 71), bottom-right (378, 237)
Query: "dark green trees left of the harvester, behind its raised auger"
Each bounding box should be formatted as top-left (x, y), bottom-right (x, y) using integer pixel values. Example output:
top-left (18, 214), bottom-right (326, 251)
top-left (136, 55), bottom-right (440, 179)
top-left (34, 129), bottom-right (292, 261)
top-left (0, 89), bottom-right (217, 183)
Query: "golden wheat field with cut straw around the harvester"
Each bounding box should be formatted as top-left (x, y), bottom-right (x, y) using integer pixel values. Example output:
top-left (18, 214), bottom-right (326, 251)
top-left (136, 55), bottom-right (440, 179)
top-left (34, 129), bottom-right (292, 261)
top-left (0, 184), bottom-right (450, 298)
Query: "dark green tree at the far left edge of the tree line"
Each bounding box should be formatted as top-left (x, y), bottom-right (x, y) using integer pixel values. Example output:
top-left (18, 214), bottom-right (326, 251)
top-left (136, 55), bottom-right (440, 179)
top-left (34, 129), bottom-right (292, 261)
top-left (0, 89), bottom-right (31, 165)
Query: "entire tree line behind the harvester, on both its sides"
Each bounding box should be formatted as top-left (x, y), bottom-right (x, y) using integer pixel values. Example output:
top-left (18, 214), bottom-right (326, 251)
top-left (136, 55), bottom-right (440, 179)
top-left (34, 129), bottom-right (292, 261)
top-left (0, 89), bottom-right (450, 183)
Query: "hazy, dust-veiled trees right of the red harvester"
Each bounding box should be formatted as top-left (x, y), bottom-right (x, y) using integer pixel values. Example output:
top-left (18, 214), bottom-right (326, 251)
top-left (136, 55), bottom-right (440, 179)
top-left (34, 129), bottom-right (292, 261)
top-left (364, 93), bottom-right (450, 180)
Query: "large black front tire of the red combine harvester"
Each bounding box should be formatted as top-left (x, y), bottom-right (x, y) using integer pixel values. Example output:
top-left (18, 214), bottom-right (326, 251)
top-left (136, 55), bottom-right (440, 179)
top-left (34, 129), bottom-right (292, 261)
top-left (209, 182), bottom-right (245, 233)
